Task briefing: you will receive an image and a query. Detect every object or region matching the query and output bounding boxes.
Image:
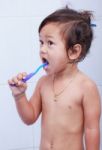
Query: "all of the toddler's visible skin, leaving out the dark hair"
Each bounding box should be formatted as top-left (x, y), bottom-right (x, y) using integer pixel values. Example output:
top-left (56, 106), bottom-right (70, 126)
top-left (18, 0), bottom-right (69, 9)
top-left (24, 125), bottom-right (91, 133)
top-left (8, 24), bottom-right (100, 150)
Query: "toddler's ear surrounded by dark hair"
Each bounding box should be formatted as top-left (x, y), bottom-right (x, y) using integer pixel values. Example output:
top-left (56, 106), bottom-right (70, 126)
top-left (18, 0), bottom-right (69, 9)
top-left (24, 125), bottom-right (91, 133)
top-left (68, 44), bottom-right (82, 61)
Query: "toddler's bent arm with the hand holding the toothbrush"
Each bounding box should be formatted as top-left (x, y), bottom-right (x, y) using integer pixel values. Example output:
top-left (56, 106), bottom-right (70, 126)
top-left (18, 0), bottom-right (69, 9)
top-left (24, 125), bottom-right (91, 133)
top-left (8, 73), bottom-right (41, 125)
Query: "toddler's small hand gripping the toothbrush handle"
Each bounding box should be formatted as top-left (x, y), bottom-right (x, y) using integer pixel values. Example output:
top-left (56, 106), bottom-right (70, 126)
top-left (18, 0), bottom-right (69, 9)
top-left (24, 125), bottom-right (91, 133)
top-left (8, 72), bottom-right (27, 97)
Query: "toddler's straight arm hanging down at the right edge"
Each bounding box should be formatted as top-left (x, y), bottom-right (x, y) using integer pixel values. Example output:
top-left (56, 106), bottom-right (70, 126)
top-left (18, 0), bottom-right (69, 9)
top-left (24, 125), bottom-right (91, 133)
top-left (83, 82), bottom-right (101, 150)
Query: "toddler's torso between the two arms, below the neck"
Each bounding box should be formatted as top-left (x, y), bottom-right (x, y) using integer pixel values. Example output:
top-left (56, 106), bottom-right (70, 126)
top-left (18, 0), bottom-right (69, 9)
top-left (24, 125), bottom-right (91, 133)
top-left (41, 75), bottom-right (83, 150)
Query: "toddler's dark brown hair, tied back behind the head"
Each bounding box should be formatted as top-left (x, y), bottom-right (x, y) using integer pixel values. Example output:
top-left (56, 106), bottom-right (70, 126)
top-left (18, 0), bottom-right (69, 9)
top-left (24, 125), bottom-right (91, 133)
top-left (39, 7), bottom-right (93, 62)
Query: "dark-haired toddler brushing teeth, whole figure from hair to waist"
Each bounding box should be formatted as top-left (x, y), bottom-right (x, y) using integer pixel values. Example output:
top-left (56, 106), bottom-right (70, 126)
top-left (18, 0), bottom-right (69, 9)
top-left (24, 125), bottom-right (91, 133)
top-left (8, 8), bottom-right (100, 150)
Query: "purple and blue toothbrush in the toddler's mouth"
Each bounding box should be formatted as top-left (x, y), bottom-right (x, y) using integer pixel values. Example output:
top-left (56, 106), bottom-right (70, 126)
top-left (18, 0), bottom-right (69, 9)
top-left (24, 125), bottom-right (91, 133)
top-left (22, 62), bottom-right (48, 82)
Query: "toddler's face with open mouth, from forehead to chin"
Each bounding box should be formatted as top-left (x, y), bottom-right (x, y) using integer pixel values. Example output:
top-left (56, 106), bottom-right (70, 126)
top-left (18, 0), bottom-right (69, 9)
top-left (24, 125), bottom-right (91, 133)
top-left (39, 23), bottom-right (68, 74)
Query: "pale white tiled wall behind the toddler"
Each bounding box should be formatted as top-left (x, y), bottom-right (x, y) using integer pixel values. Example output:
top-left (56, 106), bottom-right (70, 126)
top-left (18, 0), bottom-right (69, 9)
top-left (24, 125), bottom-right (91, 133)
top-left (0, 0), bottom-right (102, 150)
